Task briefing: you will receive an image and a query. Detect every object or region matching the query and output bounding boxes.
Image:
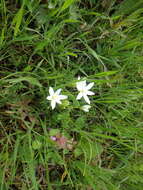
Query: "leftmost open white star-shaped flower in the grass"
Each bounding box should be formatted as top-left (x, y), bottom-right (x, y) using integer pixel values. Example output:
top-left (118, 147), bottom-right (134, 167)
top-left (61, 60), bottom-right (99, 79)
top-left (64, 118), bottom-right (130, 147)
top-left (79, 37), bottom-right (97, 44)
top-left (47, 87), bottom-right (67, 109)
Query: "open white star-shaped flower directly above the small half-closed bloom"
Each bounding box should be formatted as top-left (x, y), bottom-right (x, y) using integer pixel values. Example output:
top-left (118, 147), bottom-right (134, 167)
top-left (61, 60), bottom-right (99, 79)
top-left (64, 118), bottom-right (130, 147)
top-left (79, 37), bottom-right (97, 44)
top-left (76, 80), bottom-right (94, 104)
